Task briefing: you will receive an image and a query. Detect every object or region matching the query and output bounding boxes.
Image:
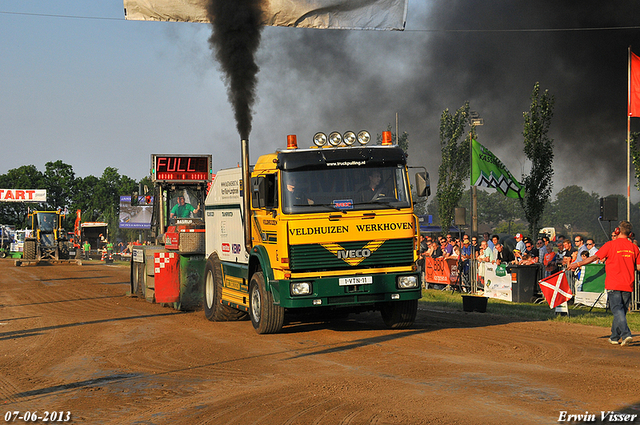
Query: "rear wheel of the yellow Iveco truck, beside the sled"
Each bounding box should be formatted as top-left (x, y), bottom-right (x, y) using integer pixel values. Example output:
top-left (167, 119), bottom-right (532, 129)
top-left (202, 254), bottom-right (247, 322)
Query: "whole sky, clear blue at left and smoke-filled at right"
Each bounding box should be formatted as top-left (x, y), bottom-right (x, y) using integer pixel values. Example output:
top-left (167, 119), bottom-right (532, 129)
top-left (0, 0), bottom-right (640, 202)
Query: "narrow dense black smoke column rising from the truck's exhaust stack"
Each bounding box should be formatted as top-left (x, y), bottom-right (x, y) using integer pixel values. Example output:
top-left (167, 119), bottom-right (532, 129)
top-left (207, 0), bottom-right (262, 139)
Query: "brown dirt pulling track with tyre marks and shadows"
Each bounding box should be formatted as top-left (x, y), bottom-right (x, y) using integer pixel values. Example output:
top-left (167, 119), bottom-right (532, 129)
top-left (0, 260), bottom-right (640, 425)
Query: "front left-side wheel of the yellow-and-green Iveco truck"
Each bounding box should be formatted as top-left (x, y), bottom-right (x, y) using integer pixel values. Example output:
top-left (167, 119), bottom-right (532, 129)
top-left (249, 272), bottom-right (284, 334)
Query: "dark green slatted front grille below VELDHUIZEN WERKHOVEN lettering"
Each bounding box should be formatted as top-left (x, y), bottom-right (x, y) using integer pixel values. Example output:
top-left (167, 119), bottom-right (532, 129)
top-left (289, 239), bottom-right (413, 272)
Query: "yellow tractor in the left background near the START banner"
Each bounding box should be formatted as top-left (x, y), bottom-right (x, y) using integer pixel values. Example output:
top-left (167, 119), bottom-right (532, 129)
top-left (22, 211), bottom-right (69, 261)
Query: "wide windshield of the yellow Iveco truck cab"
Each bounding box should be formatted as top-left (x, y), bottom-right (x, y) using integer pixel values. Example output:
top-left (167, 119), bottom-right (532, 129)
top-left (281, 166), bottom-right (411, 214)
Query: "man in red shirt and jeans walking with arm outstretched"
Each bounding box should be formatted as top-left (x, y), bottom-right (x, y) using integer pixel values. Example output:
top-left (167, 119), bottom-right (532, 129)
top-left (567, 221), bottom-right (640, 345)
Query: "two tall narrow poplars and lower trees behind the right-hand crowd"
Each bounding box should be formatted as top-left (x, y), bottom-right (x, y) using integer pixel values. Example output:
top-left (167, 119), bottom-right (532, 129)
top-left (426, 83), bottom-right (640, 242)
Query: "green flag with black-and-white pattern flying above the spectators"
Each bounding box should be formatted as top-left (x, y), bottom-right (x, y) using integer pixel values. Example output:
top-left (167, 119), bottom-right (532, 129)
top-left (471, 140), bottom-right (523, 198)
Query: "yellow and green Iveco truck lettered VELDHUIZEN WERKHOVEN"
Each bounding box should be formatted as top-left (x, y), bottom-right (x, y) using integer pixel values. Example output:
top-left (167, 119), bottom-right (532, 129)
top-left (203, 131), bottom-right (429, 334)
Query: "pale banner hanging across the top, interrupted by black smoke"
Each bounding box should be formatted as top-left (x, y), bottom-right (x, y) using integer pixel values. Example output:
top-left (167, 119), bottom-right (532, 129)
top-left (124, 0), bottom-right (408, 31)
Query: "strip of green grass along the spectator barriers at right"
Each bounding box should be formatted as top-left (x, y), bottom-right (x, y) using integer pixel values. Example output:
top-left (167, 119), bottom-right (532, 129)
top-left (420, 289), bottom-right (640, 333)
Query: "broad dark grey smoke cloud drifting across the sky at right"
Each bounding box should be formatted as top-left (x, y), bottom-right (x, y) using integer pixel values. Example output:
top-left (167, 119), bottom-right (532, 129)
top-left (255, 0), bottom-right (640, 196)
